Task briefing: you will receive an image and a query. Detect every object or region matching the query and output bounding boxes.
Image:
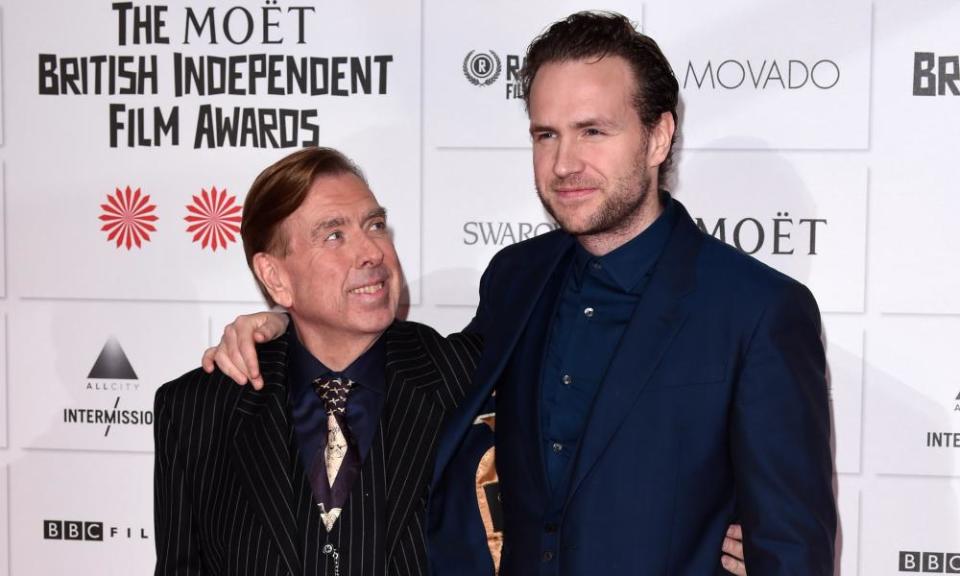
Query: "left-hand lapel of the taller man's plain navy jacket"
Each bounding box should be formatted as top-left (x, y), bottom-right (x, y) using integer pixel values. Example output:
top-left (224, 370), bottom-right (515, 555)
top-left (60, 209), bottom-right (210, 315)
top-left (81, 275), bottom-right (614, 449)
top-left (432, 233), bottom-right (574, 485)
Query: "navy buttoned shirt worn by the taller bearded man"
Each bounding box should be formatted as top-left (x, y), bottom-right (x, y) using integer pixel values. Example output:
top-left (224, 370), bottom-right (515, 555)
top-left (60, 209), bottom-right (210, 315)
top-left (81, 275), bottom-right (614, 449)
top-left (540, 197), bottom-right (675, 493)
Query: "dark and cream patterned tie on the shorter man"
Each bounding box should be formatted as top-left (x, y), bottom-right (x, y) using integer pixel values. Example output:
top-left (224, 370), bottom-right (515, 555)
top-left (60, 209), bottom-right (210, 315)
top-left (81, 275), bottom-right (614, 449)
top-left (310, 378), bottom-right (360, 532)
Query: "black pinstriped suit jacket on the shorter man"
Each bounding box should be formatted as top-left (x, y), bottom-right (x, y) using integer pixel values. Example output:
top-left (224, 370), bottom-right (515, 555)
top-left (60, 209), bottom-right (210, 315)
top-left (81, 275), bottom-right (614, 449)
top-left (154, 322), bottom-right (480, 576)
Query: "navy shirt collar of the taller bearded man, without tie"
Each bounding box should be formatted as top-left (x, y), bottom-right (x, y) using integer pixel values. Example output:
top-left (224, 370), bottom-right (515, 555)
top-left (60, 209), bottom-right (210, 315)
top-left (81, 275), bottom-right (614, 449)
top-left (573, 193), bottom-right (676, 292)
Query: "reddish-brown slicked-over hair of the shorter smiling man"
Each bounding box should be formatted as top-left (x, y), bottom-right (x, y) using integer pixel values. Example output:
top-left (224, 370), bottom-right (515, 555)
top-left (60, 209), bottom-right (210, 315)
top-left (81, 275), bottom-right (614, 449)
top-left (240, 147), bottom-right (367, 306)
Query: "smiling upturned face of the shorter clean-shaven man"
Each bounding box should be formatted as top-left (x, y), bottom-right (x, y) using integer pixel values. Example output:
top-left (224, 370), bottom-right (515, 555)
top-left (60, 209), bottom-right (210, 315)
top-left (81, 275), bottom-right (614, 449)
top-left (270, 174), bottom-right (402, 341)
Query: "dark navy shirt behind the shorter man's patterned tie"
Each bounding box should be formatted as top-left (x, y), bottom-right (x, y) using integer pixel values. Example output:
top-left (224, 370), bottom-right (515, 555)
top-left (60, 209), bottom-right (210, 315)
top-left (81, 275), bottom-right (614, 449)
top-left (287, 322), bottom-right (386, 474)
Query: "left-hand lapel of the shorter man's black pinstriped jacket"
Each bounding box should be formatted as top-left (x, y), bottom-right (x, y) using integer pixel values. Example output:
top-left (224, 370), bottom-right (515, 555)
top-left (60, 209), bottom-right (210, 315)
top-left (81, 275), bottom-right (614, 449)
top-left (232, 338), bottom-right (302, 574)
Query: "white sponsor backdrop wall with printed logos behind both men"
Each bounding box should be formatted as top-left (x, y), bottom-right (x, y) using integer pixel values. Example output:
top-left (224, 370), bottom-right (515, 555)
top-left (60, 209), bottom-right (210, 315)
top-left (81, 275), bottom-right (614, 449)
top-left (0, 0), bottom-right (960, 576)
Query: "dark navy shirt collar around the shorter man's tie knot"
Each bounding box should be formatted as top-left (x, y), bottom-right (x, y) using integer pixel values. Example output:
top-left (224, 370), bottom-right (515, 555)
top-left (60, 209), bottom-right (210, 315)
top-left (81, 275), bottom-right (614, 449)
top-left (286, 322), bottom-right (387, 400)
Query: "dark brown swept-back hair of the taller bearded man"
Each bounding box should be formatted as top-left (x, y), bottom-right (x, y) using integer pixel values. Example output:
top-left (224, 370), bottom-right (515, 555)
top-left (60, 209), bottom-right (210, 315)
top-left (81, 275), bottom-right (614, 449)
top-left (520, 12), bottom-right (680, 182)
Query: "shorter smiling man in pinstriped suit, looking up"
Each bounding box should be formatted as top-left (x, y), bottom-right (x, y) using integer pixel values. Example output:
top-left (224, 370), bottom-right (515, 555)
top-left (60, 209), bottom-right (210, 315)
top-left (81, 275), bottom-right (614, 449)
top-left (155, 148), bottom-right (479, 576)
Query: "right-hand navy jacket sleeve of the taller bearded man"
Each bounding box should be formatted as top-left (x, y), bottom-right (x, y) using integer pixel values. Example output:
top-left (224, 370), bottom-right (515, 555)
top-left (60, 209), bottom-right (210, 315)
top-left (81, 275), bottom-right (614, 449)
top-left (731, 284), bottom-right (837, 576)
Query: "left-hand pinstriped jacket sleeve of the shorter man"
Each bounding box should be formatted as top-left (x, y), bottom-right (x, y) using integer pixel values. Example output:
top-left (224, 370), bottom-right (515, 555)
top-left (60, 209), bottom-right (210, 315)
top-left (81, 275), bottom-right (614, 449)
top-left (153, 383), bottom-right (204, 576)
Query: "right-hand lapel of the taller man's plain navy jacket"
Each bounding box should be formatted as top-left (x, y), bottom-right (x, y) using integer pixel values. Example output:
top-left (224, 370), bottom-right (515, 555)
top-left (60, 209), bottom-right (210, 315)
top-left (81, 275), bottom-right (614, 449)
top-left (567, 201), bottom-right (703, 501)
